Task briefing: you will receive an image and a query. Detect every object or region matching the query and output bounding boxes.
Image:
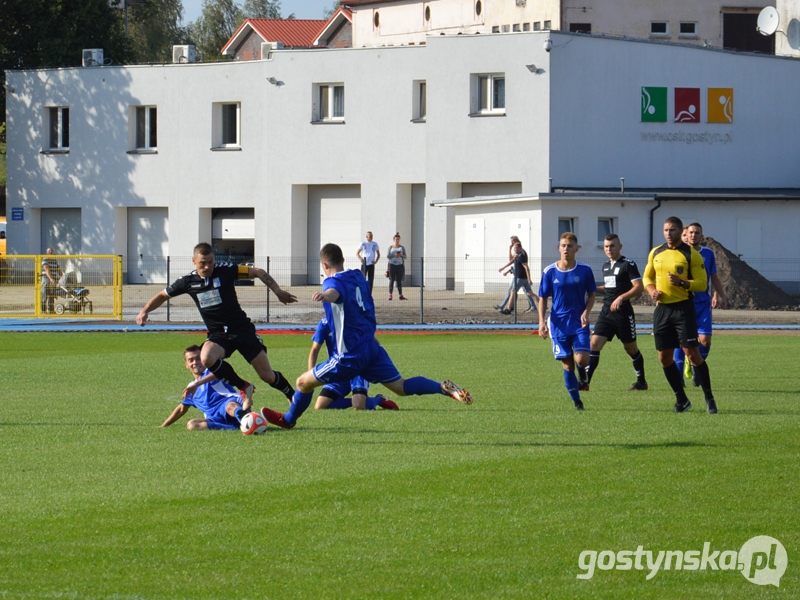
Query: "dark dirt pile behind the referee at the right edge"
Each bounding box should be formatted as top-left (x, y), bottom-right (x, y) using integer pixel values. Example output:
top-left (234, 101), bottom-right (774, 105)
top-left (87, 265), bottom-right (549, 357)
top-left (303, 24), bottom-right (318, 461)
top-left (704, 237), bottom-right (800, 310)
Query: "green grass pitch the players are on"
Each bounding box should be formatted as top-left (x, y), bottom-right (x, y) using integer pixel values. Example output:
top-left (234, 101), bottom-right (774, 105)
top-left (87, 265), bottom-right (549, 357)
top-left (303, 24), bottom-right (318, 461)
top-left (0, 333), bottom-right (800, 600)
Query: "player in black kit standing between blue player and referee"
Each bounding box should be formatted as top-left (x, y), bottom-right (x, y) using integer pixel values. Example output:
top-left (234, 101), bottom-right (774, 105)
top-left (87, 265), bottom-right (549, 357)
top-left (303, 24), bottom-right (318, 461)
top-left (580, 233), bottom-right (647, 392)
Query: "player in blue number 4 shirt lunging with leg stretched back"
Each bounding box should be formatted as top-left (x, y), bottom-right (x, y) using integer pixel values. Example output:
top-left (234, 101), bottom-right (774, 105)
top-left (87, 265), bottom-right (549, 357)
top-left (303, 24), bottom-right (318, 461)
top-left (261, 244), bottom-right (472, 429)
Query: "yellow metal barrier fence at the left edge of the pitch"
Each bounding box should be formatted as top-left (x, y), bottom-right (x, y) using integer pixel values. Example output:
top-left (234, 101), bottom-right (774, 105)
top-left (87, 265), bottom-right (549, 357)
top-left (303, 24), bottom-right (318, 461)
top-left (0, 254), bottom-right (122, 321)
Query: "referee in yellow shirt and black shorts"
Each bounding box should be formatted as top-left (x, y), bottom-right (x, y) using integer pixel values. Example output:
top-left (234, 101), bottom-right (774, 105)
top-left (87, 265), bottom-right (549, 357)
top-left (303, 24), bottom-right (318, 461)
top-left (642, 217), bottom-right (717, 414)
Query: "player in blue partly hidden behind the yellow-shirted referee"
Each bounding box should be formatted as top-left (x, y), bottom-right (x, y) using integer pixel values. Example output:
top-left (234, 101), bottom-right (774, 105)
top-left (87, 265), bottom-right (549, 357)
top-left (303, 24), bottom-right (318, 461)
top-left (674, 223), bottom-right (728, 387)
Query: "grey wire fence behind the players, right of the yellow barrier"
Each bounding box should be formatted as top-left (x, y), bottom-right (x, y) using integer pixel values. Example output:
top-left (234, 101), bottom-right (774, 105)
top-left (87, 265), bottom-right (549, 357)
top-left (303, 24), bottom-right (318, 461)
top-left (109, 256), bottom-right (800, 326)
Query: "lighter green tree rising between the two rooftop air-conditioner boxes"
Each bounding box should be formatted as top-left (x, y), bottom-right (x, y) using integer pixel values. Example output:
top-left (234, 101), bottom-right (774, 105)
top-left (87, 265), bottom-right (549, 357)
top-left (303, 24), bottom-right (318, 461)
top-left (120, 0), bottom-right (189, 63)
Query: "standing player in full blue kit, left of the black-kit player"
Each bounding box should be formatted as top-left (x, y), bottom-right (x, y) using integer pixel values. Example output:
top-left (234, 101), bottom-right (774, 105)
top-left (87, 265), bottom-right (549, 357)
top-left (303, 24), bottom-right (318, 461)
top-left (539, 232), bottom-right (597, 410)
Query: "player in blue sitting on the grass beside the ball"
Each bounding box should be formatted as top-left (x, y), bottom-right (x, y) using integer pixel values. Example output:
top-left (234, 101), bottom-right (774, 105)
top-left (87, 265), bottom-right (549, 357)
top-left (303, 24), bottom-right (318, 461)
top-left (161, 346), bottom-right (243, 431)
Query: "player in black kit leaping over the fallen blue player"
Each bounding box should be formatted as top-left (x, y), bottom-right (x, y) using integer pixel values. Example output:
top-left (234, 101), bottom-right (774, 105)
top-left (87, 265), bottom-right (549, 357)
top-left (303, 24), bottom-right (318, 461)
top-left (136, 243), bottom-right (297, 411)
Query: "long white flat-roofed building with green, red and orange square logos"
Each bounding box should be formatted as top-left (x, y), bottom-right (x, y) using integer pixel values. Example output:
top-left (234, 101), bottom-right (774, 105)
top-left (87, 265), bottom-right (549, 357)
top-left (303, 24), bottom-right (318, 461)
top-left (7, 31), bottom-right (800, 291)
